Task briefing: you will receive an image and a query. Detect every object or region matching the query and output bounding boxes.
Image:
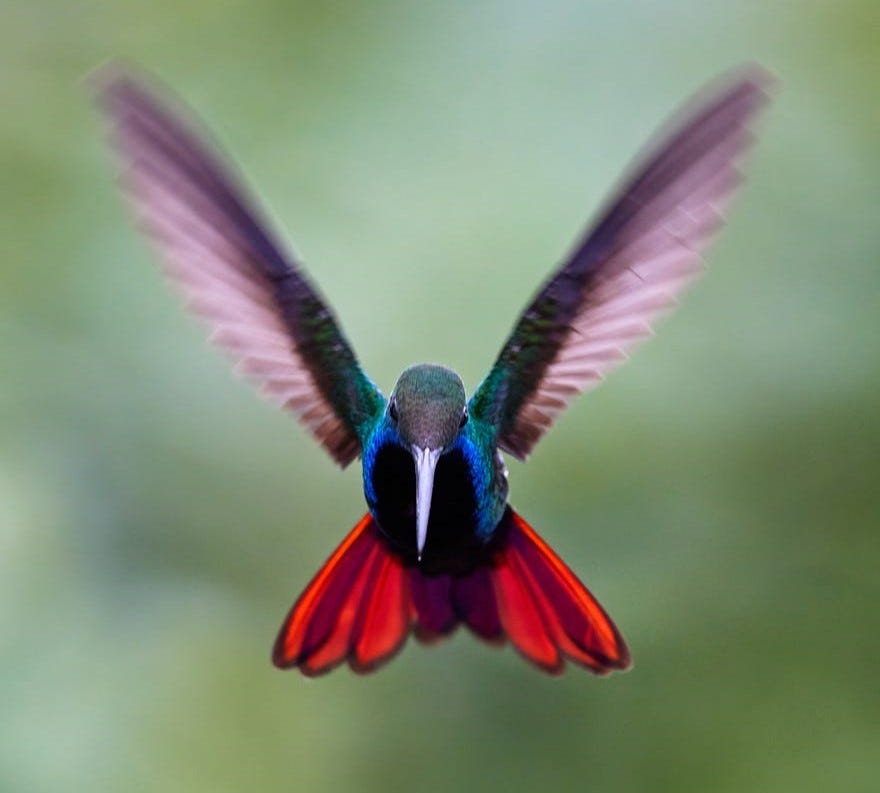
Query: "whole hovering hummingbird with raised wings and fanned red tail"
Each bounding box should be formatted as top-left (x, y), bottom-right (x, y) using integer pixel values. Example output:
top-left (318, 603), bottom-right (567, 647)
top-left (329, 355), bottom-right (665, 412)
top-left (99, 68), bottom-right (768, 675)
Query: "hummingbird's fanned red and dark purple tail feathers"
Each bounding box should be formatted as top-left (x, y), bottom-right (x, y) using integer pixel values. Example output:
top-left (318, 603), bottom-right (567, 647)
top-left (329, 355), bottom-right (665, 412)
top-left (272, 509), bottom-right (630, 675)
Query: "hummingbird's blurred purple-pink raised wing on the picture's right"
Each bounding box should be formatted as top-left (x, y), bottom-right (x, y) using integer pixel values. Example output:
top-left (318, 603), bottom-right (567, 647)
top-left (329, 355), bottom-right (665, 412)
top-left (470, 69), bottom-right (769, 459)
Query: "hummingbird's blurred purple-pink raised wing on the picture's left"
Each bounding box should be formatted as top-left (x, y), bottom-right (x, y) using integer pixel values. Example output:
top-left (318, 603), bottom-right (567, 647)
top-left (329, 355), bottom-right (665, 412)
top-left (99, 70), bottom-right (385, 466)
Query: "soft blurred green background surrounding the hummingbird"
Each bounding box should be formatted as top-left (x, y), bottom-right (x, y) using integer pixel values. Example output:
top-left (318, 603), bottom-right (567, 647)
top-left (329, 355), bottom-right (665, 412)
top-left (0, 0), bottom-right (880, 793)
